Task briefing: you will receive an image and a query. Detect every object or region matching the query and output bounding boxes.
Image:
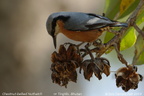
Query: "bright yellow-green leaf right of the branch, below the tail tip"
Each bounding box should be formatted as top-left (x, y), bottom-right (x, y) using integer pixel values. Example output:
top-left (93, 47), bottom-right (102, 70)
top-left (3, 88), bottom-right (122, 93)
top-left (120, 27), bottom-right (136, 51)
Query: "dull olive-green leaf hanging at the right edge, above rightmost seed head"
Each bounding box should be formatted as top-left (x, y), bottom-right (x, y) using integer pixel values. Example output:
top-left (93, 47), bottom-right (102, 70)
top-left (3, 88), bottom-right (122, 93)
top-left (133, 35), bottom-right (144, 65)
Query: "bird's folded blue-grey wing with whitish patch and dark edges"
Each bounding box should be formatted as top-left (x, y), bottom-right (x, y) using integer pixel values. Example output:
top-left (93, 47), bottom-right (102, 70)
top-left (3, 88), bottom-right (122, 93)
top-left (64, 13), bottom-right (115, 31)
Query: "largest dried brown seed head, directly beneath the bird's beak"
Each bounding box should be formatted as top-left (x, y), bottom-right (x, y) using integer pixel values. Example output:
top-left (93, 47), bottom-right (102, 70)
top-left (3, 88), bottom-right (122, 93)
top-left (51, 45), bottom-right (82, 87)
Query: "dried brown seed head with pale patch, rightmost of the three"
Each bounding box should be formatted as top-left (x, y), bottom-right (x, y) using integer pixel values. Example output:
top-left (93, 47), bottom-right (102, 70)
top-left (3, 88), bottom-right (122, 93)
top-left (115, 65), bottom-right (143, 92)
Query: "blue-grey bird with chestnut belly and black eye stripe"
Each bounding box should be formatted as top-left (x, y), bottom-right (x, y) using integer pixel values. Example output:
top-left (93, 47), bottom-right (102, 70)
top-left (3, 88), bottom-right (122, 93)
top-left (46, 12), bottom-right (128, 48)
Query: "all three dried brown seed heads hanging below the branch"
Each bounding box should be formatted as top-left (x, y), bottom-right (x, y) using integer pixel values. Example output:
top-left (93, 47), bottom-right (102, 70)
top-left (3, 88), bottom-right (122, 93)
top-left (51, 44), bottom-right (142, 91)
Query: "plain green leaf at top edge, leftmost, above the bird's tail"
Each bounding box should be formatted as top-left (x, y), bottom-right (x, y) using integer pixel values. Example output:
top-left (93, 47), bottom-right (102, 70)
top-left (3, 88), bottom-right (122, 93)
top-left (104, 0), bottom-right (121, 19)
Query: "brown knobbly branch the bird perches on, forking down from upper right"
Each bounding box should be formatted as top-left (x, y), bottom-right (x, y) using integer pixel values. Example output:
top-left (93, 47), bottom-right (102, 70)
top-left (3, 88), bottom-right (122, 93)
top-left (80, 0), bottom-right (144, 66)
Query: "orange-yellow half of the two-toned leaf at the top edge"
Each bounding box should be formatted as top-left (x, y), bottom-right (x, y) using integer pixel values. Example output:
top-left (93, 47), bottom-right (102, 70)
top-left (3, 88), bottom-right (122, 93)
top-left (120, 0), bottom-right (135, 15)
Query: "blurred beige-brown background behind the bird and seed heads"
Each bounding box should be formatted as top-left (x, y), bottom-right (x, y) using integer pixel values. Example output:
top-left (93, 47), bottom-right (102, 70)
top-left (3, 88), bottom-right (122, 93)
top-left (0, 0), bottom-right (144, 96)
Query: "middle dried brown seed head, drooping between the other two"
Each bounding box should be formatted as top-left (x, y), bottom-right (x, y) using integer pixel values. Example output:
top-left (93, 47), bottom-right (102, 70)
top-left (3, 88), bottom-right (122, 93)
top-left (81, 58), bottom-right (110, 80)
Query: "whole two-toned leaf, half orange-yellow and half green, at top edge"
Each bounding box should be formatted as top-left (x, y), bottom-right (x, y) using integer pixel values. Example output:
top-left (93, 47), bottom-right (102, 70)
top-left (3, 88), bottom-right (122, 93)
top-left (118, 0), bottom-right (140, 19)
